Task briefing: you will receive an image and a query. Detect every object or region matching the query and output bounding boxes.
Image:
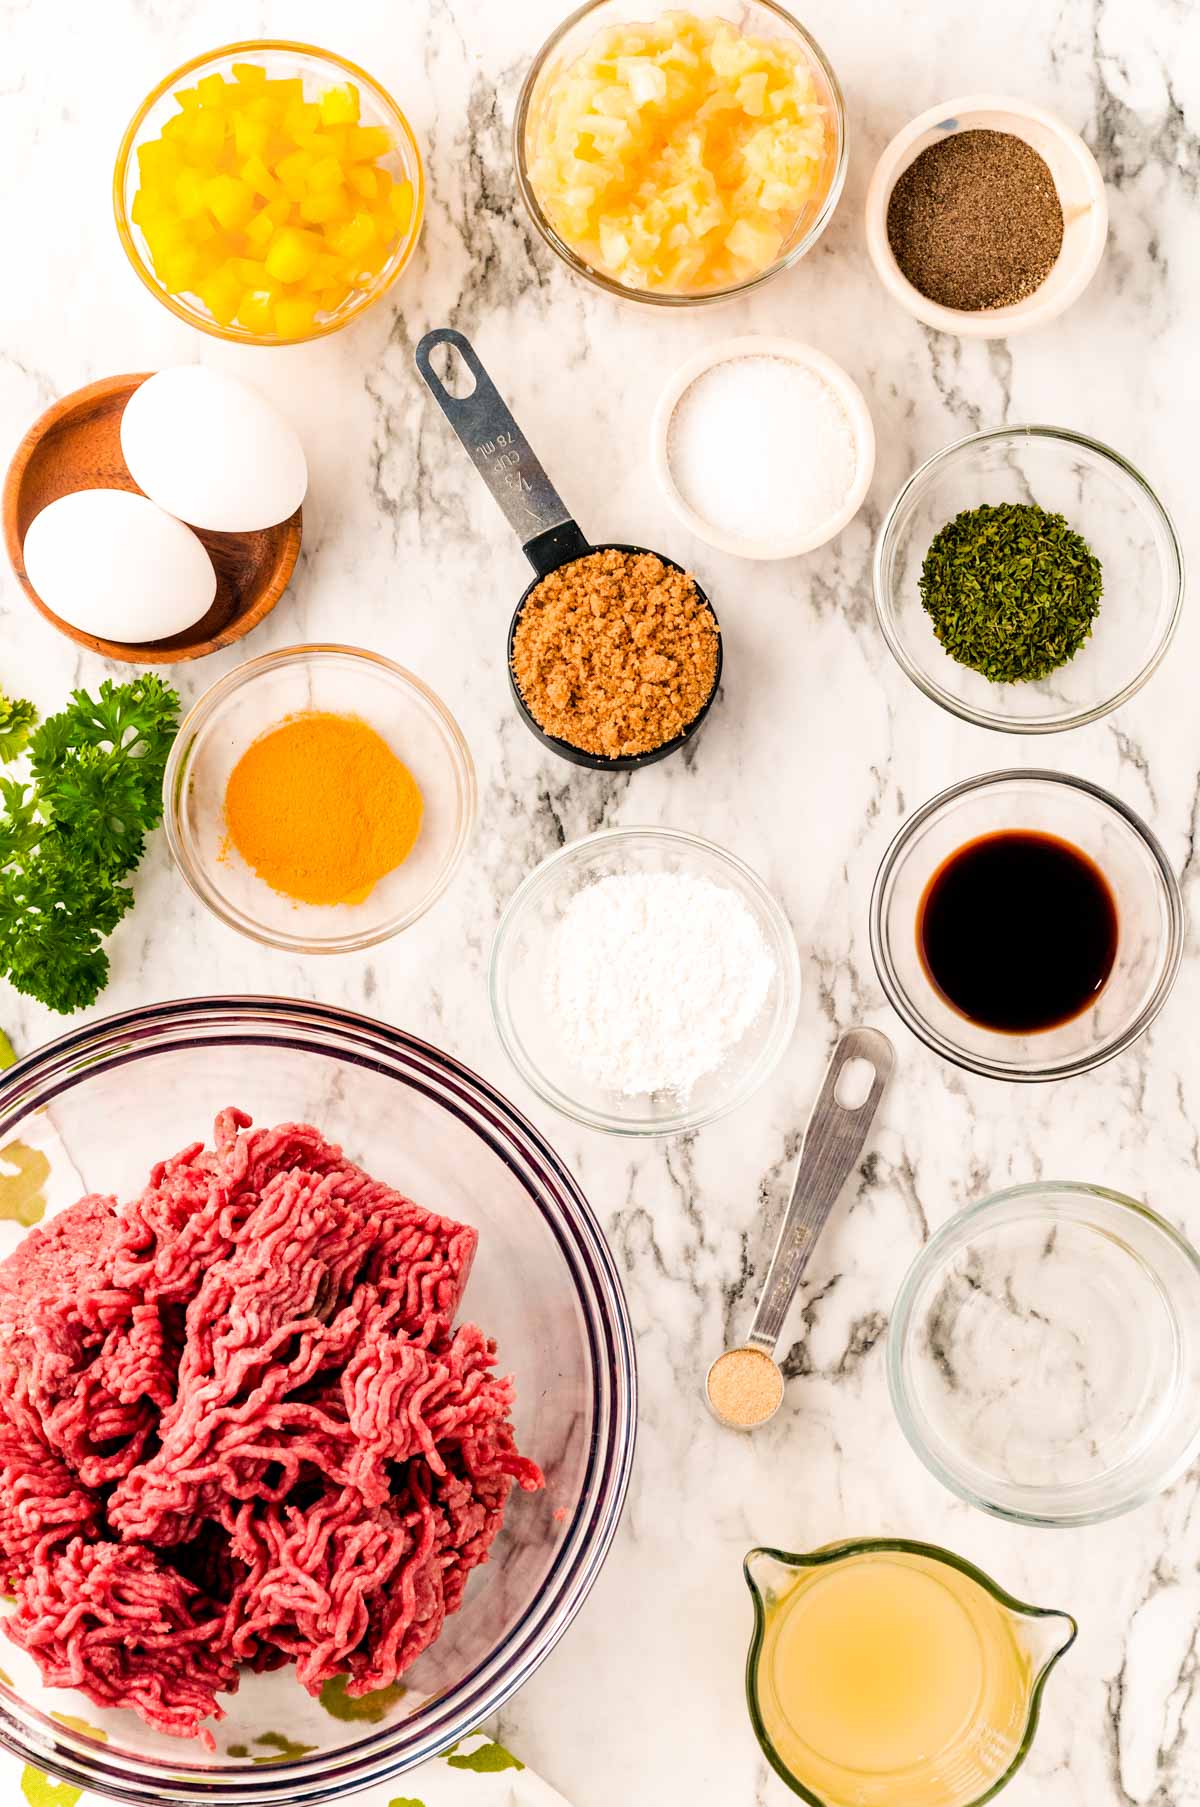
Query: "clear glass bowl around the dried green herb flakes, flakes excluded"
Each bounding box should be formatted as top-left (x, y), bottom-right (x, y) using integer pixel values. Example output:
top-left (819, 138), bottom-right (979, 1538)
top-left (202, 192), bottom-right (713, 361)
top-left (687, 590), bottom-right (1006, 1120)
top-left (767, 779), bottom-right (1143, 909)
top-left (875, 426), bottom-right (1184, 734)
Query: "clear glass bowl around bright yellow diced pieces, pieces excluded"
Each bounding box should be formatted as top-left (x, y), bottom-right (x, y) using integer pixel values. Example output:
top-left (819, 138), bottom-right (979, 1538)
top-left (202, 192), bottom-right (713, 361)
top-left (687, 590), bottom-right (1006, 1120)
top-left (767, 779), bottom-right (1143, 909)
top-left (112, 38), bottom-right (425, 345)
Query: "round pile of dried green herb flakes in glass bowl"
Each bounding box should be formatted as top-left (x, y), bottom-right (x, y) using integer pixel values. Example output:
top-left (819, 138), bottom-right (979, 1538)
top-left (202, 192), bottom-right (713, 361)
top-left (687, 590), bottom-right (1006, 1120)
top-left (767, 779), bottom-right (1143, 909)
top-left (920, 502), bottom-right (1102, 683)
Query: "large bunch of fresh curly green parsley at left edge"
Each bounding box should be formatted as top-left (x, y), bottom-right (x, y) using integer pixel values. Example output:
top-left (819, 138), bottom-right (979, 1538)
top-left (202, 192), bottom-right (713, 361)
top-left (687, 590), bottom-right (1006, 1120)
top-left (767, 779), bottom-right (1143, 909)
top-left (0, 674), bottom-right (179, 1014)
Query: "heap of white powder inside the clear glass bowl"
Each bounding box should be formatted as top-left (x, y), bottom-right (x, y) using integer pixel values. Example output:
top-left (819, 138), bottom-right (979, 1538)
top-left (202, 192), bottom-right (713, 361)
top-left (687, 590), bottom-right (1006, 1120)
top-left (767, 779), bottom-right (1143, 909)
top-left (546, 873), bottom-right (775, 1100)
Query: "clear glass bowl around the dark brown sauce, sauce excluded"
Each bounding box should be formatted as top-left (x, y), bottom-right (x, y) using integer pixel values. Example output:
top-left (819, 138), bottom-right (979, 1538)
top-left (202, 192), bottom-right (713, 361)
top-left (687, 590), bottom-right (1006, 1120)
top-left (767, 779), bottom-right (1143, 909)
top-left (871, 770), bottom-right (1186, 1081)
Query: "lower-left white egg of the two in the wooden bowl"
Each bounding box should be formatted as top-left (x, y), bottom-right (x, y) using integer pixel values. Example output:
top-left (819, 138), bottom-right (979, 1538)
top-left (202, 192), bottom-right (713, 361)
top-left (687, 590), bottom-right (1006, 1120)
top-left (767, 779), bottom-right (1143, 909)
top-left (23, 490), bottom-right (217, 641)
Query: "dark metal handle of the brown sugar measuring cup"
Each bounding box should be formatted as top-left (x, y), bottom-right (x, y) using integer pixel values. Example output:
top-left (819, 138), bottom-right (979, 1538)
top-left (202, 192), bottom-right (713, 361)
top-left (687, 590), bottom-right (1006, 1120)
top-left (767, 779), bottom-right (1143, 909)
top-left (416, 327), bottom-right (591, 576)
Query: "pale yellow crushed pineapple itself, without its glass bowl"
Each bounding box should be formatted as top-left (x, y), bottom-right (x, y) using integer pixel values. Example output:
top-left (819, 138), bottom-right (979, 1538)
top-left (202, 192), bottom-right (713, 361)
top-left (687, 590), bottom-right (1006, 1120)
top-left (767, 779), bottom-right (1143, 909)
top-left (526, 13), bottom-right (833, 295)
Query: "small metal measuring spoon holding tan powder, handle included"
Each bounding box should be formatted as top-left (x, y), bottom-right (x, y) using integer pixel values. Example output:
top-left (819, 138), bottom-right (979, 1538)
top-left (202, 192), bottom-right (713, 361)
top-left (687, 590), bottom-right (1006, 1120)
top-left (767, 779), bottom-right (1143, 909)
top-left (705, 1028), bottom-right (896, 1431)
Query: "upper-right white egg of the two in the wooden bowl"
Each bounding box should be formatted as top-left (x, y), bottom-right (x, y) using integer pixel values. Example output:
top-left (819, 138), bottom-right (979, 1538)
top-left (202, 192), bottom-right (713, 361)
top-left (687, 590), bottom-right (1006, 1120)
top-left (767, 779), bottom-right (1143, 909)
top-left (121, 363), bottom-right (309, 533)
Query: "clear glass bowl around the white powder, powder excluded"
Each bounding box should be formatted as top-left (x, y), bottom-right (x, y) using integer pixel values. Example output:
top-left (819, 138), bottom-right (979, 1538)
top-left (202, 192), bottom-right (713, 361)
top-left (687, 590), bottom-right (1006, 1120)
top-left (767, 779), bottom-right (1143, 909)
top-left (488, 828), bottom-right (801, 1135)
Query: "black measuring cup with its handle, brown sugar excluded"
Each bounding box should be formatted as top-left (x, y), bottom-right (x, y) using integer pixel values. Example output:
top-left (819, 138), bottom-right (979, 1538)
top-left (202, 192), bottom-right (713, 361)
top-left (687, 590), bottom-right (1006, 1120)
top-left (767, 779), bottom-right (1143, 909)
top-left (416, 327), bottom-right (725, 772)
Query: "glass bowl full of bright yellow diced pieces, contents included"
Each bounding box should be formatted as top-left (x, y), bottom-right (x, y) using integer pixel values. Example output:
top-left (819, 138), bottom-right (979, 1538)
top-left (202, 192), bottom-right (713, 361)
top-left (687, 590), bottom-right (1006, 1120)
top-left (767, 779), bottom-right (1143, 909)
top-left (112, 40), bottom-right (425, 345)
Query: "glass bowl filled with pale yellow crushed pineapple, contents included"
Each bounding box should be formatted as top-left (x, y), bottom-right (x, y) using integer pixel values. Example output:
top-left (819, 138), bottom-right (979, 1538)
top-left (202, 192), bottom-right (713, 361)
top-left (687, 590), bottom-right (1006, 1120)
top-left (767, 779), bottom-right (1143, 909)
top-left (515, 0), bottom-right (846, 307)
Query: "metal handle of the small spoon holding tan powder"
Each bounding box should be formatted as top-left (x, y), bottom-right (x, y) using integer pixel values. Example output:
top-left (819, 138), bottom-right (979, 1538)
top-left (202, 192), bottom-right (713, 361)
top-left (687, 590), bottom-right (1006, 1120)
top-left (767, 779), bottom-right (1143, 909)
top-left (746, 1028), bottom-right (896, 1355)
